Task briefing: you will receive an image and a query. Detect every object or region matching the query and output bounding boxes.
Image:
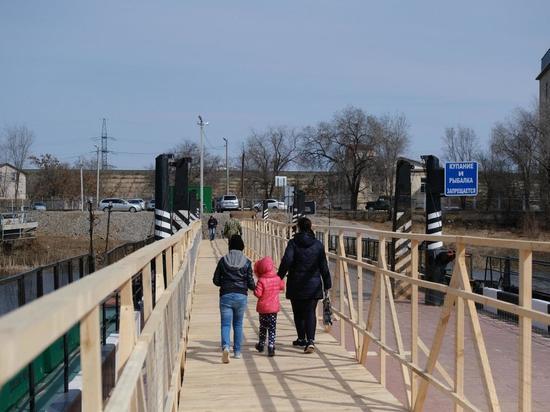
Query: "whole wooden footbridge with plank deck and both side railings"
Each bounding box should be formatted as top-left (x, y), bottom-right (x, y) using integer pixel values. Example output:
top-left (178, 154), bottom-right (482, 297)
top-left (0, 220), bottom-right (550, 412)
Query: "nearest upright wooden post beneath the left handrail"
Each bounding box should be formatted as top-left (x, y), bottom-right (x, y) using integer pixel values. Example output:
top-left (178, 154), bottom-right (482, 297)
top-left (80, 306), bottom-right (103, 412)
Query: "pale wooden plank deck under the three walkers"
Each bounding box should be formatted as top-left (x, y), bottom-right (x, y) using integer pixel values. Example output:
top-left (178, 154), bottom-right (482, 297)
top-left (180, 240), bottom-right (403, 412)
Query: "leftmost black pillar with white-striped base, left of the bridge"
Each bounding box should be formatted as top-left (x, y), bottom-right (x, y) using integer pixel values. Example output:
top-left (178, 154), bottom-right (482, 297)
top-left (155, 154), bottom-right (173, 240)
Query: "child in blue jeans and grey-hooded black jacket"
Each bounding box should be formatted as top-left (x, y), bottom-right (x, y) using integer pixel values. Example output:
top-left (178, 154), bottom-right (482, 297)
top-left (212, 235), bottom-right (256, 363)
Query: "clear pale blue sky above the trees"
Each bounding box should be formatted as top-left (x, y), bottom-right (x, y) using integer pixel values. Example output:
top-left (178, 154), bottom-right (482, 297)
top-left (0, 0), bottom-right (550, 169)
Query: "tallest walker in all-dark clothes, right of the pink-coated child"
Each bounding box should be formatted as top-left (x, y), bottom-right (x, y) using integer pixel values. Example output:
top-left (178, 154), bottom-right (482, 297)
top-left (277, 217), bottom-right (332, 353)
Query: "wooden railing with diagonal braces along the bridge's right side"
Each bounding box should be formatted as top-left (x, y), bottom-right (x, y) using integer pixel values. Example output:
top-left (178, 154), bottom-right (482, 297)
top-left (242, 220), bottom-right (550, 411)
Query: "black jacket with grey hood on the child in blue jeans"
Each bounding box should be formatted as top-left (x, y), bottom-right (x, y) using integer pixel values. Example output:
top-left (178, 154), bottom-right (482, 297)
top-left (212, 250), bottom-right (256, 296)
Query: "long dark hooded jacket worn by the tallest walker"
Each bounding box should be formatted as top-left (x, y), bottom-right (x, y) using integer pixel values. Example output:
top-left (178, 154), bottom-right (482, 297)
top-left (278, 233), bottom-right (332, 299)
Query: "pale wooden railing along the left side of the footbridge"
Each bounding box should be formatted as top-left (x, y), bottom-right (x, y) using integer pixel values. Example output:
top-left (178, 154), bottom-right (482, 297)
top-left (0, 222), bottom-right (201, 411)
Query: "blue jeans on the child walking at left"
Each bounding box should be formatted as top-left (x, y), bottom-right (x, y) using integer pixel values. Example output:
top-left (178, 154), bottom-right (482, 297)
top-left (220, 293), bottom-right (247, 353)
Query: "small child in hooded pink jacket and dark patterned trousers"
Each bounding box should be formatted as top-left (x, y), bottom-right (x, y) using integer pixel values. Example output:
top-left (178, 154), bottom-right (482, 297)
top-left (254, 256), bottom-right (285, 356)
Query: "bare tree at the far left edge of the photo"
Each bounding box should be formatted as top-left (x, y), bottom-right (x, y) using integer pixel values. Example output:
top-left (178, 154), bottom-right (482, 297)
top-left (2, 125), bottom-right (34, 199)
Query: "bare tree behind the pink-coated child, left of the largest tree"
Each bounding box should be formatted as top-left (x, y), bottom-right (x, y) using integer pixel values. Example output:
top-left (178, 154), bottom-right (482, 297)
top-left (245, 126), bottom-right (299, 199)
